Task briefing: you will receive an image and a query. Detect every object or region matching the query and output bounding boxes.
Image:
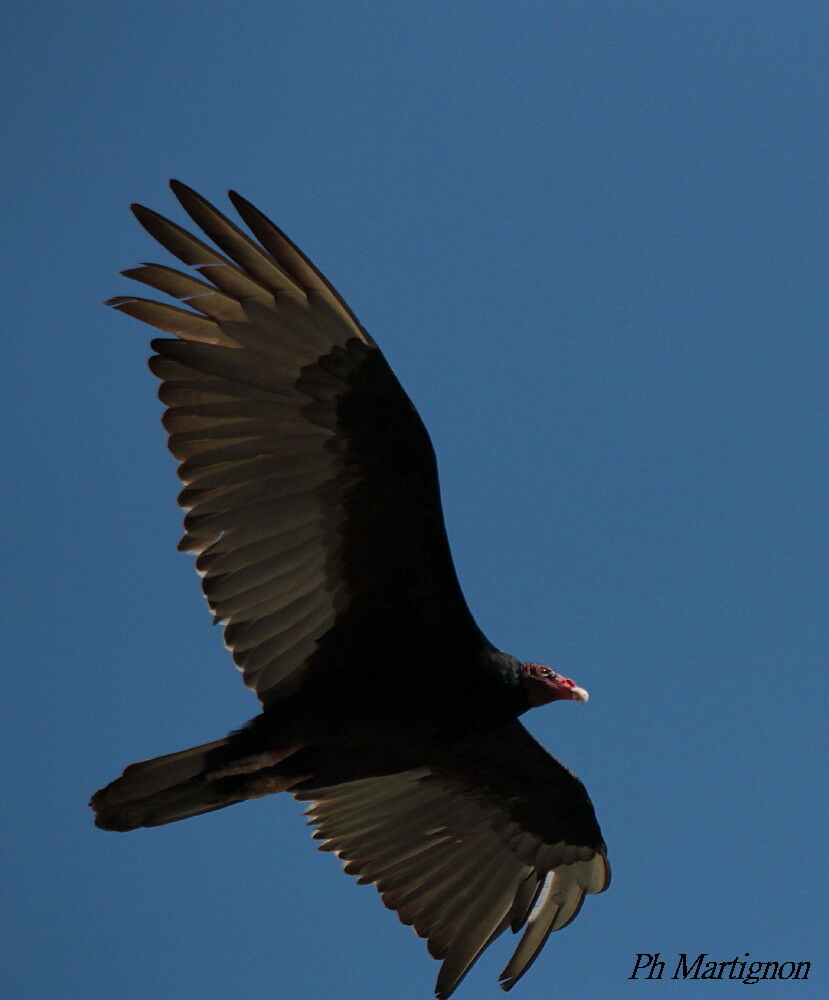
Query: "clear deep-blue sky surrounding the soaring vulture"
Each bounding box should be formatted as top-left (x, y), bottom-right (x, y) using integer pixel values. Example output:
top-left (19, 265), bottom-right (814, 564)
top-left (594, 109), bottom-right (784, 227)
top-left (0, 0), bottom-right (829, 1000)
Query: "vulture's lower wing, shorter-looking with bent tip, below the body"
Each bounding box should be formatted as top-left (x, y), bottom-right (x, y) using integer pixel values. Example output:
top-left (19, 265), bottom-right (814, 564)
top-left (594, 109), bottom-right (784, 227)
top-left (295, 722), bottom-right (610, 998)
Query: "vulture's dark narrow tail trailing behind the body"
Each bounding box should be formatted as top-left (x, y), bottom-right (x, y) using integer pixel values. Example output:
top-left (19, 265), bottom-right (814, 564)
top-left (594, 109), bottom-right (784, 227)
top-left (89, 731), bottom-right (307, 831)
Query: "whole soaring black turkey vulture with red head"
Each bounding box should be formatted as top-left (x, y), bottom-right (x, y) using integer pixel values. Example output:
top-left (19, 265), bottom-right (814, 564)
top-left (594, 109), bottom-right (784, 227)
top-left (91, 181), bottom-right (610, 998)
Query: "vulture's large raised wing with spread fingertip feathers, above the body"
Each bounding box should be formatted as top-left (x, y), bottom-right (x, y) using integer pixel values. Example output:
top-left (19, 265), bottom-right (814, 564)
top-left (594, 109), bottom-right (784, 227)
top-left (110, 181), bottom-right (485, 704)
